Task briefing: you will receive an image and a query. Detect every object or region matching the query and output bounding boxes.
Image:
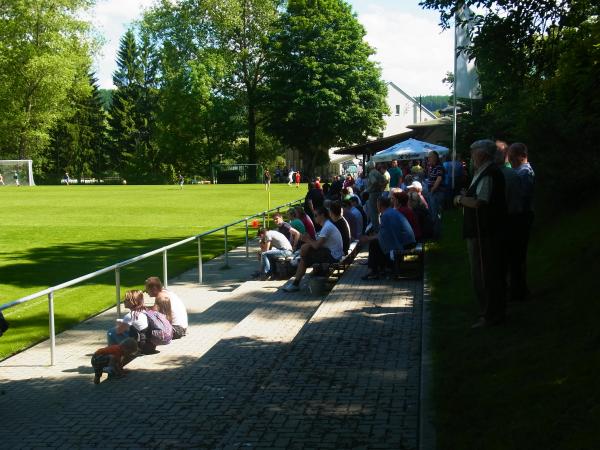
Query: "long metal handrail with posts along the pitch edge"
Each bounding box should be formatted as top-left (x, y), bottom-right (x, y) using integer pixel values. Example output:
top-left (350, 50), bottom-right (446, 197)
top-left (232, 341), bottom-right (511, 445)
top-left (0, 199), bottom-right (303, 365)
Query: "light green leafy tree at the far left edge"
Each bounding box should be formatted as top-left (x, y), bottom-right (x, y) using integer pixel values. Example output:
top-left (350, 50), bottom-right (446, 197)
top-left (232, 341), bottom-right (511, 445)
top-left (0, 0), bottom-right (94, 162)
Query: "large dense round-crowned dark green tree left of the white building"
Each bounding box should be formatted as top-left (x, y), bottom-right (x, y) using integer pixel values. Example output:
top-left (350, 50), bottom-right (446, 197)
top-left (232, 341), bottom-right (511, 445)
top-left (268, 0), bottom-right (387, 175)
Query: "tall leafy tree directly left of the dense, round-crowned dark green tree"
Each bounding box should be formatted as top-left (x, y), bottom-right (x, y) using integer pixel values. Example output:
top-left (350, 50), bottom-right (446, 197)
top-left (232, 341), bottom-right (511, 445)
top-left (143, 1), bottom-right (248, 178)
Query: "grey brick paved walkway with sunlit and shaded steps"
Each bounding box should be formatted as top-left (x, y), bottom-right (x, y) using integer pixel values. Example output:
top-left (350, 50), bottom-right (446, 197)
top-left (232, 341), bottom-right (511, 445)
top-left (0, 244), bottom-right (423, 449)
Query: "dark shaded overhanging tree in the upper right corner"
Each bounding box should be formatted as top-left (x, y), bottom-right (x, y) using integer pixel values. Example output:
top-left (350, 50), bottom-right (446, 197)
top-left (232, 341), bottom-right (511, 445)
top-left (421, 0), bottom-right (600, 205)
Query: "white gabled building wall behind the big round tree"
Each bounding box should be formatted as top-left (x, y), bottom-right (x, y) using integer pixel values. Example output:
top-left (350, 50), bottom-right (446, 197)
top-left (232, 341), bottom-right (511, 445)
top-left (380, 81), bottom-right (436, 137)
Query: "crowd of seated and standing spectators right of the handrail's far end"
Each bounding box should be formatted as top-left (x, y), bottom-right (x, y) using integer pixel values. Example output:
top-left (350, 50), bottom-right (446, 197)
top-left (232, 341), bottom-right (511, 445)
top-left (258, 140), bottom-right (534, 327)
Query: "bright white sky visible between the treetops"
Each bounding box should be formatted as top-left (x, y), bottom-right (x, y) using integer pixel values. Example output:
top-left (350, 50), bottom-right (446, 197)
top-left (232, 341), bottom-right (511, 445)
top-left (92, 0), bottom-right (454, 96)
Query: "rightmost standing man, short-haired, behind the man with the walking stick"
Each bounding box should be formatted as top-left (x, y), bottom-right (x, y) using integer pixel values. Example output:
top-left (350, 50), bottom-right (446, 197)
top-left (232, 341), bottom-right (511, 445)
top-left (508, 142), bottom-right (535, 301)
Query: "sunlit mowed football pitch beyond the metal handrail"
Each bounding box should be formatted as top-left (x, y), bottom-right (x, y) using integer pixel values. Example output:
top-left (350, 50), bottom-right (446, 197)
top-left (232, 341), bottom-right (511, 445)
top-left (0, 184), bottom-right (305, 359)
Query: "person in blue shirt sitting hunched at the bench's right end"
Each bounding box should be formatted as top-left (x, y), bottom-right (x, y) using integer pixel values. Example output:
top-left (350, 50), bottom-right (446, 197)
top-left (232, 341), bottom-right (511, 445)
top-left (360, 197), bottom-right (416, 280)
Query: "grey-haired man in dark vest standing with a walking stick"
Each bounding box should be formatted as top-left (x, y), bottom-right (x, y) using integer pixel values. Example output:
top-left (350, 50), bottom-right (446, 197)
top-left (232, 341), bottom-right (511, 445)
top-left (454, 139), bottom-right (506, 328)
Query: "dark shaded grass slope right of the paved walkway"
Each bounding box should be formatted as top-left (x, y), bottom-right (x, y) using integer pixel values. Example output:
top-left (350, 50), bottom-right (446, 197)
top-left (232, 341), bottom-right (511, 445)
top-left (427, 205), bottom-right (600, 450)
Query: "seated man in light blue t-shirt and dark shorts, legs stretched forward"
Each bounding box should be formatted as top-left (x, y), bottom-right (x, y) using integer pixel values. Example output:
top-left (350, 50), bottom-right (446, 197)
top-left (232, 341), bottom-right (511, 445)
top-left (283, 207), bottom-right (344, 292)
